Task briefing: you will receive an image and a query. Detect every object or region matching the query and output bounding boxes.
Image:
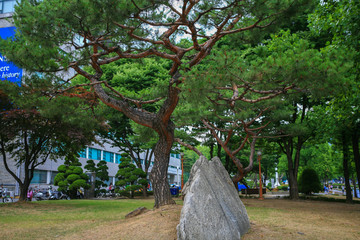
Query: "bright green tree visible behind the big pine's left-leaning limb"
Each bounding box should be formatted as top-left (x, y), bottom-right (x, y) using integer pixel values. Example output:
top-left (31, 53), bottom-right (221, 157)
top-left (95, 58), bottom-right (171, 196)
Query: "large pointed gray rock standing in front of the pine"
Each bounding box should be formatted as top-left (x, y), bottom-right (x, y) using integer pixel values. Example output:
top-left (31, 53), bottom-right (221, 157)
top-left (177, 157), bottom-right (250, 240)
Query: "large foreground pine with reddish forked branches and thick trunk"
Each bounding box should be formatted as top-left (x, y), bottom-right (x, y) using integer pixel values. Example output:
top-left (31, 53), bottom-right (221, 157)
top-left (0, 0), bottom-right (308, 207)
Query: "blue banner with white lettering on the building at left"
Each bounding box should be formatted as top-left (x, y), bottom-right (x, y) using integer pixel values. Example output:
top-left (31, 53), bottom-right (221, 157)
top-left (0, 27), bottom-right (22, 84)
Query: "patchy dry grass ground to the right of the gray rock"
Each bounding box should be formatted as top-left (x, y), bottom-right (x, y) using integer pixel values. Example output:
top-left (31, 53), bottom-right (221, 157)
top-left (243, 199), bottom-right (360, 240)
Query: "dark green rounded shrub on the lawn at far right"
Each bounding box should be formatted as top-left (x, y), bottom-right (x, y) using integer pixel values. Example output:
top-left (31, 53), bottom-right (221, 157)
top-left (298, 168), bottom-right (322, 195)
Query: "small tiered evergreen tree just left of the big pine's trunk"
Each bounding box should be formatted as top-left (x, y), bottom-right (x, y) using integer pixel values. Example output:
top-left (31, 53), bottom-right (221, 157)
top-left (115, 153), bottom-right (147, 198)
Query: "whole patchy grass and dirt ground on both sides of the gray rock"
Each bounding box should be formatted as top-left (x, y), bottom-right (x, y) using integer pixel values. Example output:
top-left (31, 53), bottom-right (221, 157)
top-left (0, 199), bottom-right (360, 240)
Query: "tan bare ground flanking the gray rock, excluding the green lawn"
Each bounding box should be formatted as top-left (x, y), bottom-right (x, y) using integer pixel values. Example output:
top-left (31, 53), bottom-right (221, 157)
top-left (62, 199), bottom-right (360, 240)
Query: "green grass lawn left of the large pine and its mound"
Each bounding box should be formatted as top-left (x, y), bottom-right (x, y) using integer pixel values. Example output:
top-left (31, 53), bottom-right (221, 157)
top-left (0, 199), bottom-right (158, 239)
